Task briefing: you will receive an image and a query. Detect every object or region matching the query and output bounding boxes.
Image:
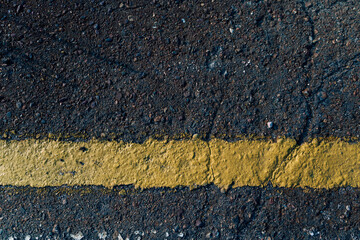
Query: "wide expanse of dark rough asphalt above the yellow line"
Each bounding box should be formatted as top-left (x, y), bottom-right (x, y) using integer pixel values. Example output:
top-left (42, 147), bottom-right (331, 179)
top-left (0, 0), bottom-right (360, 143)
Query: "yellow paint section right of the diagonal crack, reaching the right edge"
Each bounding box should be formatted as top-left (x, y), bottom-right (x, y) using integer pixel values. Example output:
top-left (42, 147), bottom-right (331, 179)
top-left (272, 139), bottom-right (360, 188)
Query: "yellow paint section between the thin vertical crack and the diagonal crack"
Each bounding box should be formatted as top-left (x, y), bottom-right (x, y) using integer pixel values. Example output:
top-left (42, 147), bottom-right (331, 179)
top-left (209, 139), bottom-right (296, 188)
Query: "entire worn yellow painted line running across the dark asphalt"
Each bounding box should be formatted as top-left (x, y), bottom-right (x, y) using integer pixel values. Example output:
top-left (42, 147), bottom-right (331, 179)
top-left (0, 139), bottom-right (360, 188)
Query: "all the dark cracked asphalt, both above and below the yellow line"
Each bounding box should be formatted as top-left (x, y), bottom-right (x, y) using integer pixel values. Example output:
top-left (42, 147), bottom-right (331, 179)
top-left (0, 0), bottom-right (360, 239)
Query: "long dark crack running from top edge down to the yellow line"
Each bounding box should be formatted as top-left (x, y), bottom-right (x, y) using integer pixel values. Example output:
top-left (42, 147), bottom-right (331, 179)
top-left (297, 1), bottom-right (316, 145)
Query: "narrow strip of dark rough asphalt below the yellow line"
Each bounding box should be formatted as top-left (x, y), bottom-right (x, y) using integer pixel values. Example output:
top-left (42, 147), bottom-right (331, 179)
top-left (0, 186), bottom-right (360, 240)
